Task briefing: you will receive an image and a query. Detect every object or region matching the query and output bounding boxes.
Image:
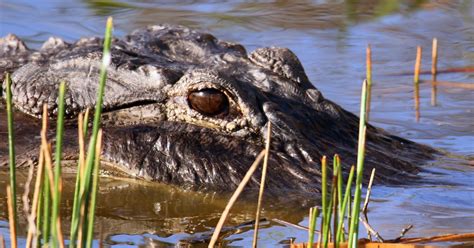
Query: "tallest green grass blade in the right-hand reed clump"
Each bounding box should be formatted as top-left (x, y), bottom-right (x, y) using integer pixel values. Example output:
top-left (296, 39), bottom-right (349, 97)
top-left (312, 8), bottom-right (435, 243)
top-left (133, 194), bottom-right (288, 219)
top-left (349, 80), bottom-right (367, 247)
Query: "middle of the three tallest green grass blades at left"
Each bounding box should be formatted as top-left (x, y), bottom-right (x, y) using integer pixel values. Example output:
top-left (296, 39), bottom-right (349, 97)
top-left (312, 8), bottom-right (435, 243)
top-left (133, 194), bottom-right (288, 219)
top-left (51, 82), bottom-right (66, 247)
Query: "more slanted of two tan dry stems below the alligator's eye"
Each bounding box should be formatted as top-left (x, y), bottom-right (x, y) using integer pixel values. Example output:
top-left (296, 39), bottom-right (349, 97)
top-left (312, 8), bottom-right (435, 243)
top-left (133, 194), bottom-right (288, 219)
top-left (208, 150), bottom-right (265, 248)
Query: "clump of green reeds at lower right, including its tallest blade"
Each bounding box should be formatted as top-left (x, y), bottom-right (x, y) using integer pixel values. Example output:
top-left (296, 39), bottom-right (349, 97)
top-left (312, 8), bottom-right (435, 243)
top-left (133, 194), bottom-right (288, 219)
top-left (308, 80), bottom-right (368, 248)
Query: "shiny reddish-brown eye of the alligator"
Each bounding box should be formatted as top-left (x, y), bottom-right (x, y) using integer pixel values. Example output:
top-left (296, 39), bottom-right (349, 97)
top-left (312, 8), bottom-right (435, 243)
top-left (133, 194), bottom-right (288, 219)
top-left (188, 89), bottom-right (229, 116)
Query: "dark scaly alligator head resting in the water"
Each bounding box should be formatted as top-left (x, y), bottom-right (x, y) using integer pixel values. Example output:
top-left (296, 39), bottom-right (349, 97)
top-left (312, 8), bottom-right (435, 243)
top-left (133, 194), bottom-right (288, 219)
top-left (0, 25), bottom-right (438, 195)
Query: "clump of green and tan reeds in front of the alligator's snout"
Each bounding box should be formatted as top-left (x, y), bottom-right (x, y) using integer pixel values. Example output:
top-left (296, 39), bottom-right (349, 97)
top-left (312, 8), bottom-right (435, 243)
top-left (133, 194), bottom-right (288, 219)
top-left (6, 18), bottom-right (113, 247)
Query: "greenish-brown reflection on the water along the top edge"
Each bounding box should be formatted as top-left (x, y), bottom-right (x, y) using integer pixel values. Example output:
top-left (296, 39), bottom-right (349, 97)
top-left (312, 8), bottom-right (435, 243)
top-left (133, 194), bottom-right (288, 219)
top-left (84, 0), bottom-right (434, 30)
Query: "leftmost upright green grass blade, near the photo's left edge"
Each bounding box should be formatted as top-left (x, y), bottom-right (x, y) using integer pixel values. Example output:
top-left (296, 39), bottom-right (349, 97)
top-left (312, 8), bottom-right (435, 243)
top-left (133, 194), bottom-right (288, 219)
top-left (5, 73), bottom-right (17, 232)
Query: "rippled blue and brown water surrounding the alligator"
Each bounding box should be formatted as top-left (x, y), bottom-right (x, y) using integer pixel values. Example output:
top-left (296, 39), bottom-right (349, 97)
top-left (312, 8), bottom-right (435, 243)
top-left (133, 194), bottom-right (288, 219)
top-left (0, 0), bottom-right (474, 247)
